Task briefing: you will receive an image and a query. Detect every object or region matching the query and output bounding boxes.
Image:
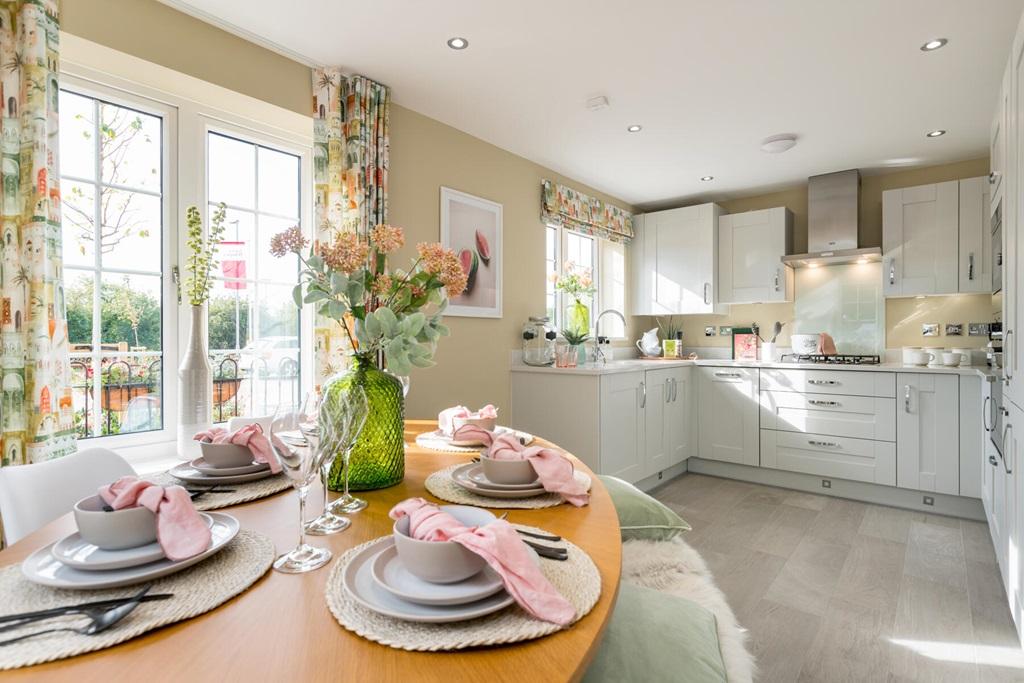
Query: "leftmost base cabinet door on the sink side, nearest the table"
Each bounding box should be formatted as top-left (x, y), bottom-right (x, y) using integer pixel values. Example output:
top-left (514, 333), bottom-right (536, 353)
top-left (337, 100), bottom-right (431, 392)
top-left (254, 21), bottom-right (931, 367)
top-left (595, 372), bottom-right (647, 483)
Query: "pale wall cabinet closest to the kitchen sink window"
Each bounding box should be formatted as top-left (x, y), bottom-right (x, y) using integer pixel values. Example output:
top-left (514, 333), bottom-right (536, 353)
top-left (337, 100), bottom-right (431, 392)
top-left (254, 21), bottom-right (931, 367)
top-left (630, 204), bottom-right (728, 315)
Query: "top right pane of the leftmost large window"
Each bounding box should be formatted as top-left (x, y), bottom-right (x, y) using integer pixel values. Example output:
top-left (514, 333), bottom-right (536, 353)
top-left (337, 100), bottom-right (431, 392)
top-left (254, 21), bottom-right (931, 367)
top-left (99, 102), bottom-right (162, 193)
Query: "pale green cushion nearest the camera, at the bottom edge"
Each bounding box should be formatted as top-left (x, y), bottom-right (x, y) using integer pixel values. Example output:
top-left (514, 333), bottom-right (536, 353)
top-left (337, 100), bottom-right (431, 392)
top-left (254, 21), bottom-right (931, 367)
top-left (583, 583), bottom-right (728, 683)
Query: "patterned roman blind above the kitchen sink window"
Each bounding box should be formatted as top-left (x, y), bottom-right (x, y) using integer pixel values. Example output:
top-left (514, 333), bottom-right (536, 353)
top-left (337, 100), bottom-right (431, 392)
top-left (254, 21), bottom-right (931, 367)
top-left (541, 180), bottom-right (633, 244)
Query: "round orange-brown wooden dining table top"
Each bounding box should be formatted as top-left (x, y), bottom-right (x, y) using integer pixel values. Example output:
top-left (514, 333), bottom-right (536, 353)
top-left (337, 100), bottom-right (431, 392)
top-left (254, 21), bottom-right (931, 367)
top-left (0, 421), bottom-right (622, 683)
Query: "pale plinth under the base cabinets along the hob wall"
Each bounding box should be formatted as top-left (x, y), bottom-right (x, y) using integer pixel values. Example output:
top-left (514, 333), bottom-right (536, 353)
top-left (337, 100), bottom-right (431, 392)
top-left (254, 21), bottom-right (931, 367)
top-left (679, 458), bottom-right (985, 521)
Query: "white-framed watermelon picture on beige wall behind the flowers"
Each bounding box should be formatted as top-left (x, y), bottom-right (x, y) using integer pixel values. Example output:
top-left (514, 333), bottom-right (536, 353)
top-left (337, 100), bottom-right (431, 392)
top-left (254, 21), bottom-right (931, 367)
top-left (440, 186), bottom-right (504, 317)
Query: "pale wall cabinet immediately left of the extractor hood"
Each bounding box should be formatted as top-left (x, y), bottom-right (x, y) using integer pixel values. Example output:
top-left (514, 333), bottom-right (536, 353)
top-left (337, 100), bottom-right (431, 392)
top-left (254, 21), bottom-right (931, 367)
top-left (718, 207), bottom-right (794, 303)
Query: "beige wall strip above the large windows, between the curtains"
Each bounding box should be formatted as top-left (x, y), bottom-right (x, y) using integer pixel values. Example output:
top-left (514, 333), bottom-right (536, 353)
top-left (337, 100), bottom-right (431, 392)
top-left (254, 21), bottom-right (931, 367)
top-left (60, 0), bottom-right (312, 114)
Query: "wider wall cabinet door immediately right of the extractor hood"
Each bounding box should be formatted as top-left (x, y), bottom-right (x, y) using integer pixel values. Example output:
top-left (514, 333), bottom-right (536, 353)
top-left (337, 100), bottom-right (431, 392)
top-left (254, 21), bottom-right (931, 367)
top-left (882, 180), bottom-right (959, 297)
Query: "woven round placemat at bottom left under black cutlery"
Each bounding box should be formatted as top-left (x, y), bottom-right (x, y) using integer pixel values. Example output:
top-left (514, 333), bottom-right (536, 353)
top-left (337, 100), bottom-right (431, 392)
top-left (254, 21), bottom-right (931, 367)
top-left (0, 529), bottom-right (274, 671)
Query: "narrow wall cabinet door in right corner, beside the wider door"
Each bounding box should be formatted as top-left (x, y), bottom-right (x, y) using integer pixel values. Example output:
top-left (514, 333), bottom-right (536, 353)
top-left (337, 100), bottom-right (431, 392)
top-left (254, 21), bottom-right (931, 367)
top-left (957, 176), bottom-right (992, 294)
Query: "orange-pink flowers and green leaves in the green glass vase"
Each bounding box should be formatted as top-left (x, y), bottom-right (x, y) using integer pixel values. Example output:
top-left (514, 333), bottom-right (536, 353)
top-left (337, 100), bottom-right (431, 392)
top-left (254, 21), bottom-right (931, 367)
top-left (270, 225), bottom-right (466, 375)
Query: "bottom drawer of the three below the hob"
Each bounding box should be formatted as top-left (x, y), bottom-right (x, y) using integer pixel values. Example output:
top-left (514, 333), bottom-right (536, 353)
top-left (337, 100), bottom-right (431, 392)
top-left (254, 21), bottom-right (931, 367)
top-left (761, 429), bottom-right (896, 486)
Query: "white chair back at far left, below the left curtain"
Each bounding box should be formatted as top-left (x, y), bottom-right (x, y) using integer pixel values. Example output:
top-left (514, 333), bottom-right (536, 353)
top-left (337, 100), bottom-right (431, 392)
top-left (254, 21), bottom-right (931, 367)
top-left (0, 449), bottom-right (135, 544)
